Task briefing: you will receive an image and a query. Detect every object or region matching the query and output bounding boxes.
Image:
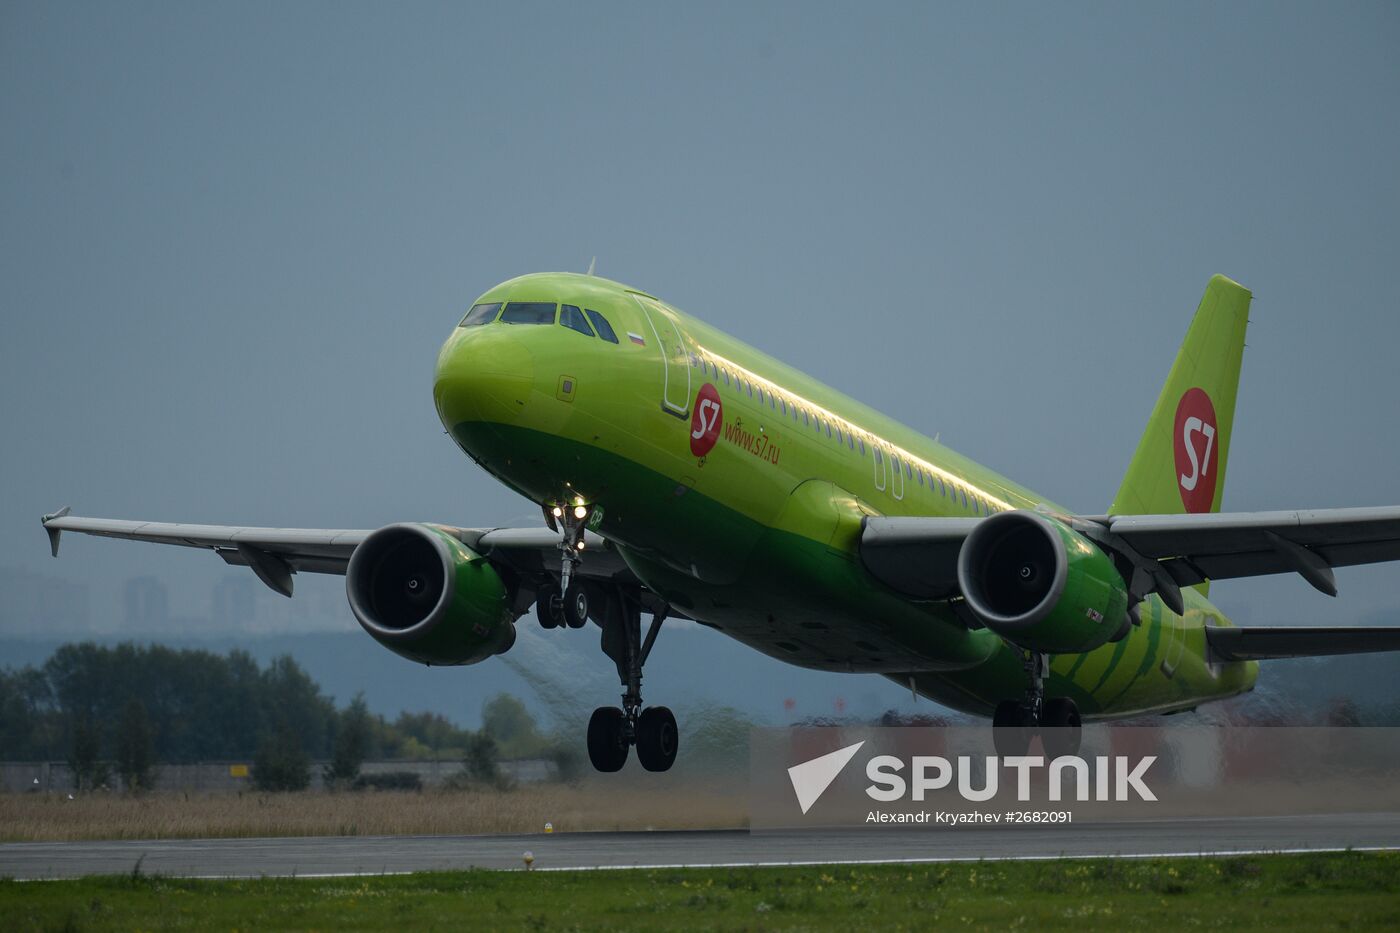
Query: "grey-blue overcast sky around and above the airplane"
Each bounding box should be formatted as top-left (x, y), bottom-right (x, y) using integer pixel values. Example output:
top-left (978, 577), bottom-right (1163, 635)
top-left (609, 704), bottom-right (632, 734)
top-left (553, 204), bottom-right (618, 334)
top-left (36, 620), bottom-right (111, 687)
top-left (0, 1), bottom-right (1400, 633)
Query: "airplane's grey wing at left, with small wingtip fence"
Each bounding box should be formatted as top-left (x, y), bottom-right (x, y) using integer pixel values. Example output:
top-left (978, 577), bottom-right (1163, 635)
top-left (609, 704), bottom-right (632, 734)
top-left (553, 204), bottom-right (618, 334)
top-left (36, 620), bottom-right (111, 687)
top-left (43, 509), bottom-right (626, 597)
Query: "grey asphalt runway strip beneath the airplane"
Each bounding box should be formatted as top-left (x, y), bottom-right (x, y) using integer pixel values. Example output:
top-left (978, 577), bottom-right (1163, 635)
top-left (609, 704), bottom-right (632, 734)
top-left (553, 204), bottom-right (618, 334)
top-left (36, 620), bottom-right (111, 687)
top-left (8, 814), bottom-right (1400, 880)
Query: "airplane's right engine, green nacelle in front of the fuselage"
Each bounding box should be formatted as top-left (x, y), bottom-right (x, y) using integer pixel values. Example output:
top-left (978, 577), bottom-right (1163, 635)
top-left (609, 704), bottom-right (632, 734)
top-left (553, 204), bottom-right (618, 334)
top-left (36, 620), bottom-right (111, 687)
top-left (958, 511), bottom-right (1128, 654)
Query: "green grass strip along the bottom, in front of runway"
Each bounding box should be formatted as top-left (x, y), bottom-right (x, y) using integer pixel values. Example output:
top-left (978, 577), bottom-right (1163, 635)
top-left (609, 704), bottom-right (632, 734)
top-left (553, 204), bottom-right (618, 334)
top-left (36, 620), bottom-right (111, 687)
top-left (0, 853), bottom-right (1400, 932)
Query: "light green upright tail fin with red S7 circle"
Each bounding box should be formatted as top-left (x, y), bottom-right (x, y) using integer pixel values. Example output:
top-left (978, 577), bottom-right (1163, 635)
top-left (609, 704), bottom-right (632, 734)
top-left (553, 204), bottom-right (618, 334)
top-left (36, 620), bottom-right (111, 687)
top-left (1109, 276), bottom-right (1250, 516)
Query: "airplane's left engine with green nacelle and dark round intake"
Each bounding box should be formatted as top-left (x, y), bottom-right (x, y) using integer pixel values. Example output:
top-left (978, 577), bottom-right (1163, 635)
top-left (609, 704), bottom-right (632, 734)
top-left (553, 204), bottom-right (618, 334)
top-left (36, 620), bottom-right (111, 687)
top-left (346, 524), bottom-right (515, 664)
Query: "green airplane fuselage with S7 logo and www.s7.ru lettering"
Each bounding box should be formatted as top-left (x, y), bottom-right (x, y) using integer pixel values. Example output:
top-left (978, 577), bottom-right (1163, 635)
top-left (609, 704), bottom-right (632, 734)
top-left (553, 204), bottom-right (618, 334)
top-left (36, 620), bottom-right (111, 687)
top-left (434, 273), bottom-right (1257, 719)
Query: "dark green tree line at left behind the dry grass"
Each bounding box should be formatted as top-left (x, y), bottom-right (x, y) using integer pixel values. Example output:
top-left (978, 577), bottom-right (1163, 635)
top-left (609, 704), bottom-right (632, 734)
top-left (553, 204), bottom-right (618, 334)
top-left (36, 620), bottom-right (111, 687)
top-left (0, 642), bottom-right (567, 790)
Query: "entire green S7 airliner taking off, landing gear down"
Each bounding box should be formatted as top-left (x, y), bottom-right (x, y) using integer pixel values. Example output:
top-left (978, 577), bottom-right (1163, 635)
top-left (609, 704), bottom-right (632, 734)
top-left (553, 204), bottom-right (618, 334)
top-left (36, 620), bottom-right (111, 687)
top-left (43, 273), bottom-right (1400, 772)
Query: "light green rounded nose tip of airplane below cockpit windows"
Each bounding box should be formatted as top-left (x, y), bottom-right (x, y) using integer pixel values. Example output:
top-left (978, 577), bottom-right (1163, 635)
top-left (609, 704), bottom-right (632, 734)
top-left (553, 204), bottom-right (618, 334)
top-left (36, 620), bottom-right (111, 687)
top-left (433, 326), bottom-right (535, 431)
